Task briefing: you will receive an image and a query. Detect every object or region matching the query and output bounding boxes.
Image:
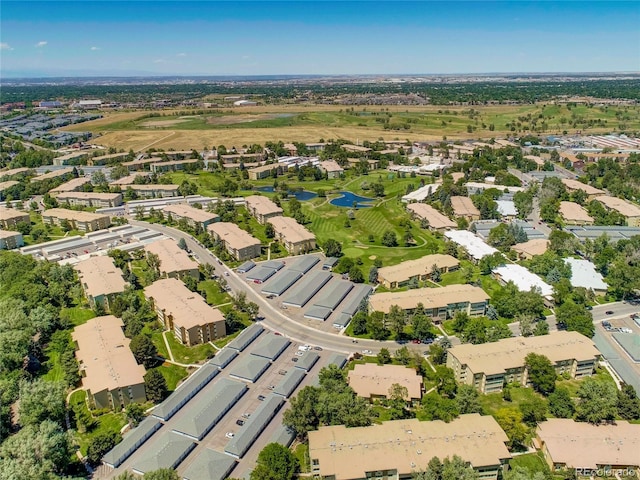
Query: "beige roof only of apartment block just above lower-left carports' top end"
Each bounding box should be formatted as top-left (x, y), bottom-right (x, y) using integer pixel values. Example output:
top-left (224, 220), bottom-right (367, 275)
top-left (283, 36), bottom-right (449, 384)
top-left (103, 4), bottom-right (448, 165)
top-left (144, 278), bottom-right (224, 330)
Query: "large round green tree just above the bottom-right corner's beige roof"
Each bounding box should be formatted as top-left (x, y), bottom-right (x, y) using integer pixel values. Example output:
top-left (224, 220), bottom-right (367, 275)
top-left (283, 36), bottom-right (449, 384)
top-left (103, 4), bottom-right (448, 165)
top-left (576, 377), bottom-right (618, 424)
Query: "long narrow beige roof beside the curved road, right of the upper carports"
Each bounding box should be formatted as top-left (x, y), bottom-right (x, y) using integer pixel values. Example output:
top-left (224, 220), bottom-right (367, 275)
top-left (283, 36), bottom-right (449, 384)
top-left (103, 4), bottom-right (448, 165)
top-left (369, 285), bottom-right (489, 313)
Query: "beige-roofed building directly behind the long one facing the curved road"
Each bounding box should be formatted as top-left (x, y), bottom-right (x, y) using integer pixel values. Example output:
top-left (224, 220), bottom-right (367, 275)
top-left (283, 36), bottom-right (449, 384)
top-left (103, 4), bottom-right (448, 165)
top-left (378, 254), bottom-right (460, 288)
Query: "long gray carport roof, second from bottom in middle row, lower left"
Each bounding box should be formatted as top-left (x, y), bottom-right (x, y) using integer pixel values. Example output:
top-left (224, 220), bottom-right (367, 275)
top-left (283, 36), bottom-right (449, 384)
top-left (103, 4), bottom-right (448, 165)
top-left (173, 378), bottom-right (249, 440)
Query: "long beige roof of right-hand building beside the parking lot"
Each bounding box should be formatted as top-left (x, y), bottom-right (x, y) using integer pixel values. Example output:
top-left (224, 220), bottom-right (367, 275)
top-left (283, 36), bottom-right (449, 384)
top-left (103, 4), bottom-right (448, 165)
top-left (449, 331), bottom-right (600, 375)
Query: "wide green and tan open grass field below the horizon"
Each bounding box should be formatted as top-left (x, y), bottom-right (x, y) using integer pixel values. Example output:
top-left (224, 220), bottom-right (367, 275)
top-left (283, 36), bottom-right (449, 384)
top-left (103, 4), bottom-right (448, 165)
top-left (64, 104), bottom-right (640, 151)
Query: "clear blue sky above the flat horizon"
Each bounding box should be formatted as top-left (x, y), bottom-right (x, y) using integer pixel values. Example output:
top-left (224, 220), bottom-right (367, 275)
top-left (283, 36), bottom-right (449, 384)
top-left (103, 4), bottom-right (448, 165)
top-left (0, 0), bottom-right (640, 76)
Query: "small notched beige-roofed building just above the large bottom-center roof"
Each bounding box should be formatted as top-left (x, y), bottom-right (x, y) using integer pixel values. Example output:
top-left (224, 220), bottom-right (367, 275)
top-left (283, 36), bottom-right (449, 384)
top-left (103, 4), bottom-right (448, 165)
top-left (347, 363), bottom-right (422, 403)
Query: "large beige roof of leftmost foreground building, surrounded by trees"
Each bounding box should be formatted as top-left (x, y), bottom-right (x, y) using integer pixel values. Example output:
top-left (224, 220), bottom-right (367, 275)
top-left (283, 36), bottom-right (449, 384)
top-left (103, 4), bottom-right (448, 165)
top-left (71, 315), bottom-right (145, 394)
